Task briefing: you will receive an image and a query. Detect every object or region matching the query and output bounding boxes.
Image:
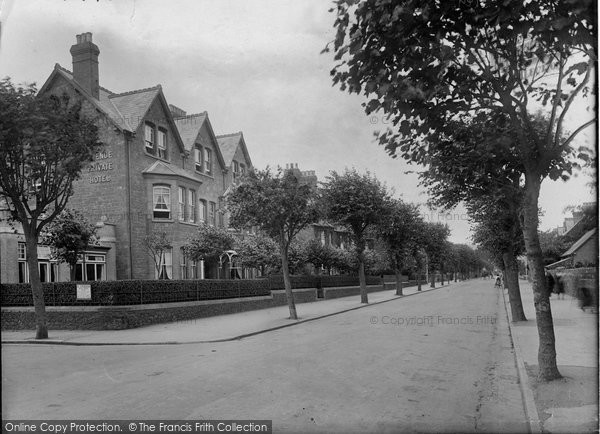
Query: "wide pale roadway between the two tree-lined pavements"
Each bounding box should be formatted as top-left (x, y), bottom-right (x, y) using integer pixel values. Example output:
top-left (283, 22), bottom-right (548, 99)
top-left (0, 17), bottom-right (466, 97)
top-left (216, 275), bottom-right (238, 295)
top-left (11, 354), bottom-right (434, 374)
top-left (2, 279), bottom-right (527, 432)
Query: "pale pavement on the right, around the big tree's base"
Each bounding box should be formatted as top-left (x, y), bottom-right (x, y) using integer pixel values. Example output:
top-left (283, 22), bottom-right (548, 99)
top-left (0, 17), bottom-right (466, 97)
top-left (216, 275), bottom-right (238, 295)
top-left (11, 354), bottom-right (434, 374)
top-left (505, 280), bottom-right (598, 433)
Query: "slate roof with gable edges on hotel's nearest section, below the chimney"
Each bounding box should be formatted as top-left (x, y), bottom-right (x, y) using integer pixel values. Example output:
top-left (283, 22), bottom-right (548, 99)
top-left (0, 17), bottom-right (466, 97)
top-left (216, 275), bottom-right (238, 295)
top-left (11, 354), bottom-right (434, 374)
top-left (39, 63), bottom-right (185, 152)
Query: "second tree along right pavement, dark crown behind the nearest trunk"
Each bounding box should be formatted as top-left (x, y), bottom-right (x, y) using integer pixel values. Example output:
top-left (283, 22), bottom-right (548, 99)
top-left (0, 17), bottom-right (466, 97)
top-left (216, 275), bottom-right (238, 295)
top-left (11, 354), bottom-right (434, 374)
top-left (420, 114), bottom-right (525, 321)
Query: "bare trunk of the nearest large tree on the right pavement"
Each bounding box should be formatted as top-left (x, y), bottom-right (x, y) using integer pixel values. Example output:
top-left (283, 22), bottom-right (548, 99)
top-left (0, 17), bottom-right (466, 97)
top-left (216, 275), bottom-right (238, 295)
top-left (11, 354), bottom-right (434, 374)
top-left (521, 173), bottom-right (562, 381)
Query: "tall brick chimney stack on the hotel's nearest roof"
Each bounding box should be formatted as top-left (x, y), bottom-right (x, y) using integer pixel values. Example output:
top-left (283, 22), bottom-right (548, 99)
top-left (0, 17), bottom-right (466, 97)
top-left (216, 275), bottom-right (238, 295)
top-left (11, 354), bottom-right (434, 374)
top-left (71, 32), bottom-right (100, 99)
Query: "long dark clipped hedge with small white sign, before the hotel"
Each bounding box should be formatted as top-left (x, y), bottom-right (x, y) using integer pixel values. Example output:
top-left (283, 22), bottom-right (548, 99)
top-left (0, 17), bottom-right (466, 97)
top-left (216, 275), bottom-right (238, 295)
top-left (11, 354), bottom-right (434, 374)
top-left (0, 279), bottom-right (271, 306)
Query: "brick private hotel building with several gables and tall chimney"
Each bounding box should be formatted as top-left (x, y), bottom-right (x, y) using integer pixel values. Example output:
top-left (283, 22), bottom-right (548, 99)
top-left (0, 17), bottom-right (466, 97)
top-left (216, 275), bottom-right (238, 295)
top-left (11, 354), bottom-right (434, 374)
top-left (0, 33), bottom-right (252, 282)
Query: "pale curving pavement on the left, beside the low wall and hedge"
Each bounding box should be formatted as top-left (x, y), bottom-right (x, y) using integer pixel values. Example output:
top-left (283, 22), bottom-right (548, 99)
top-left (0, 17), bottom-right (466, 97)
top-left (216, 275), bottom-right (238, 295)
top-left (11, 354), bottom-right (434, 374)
top-left (2, 284), bottom-right (449, 345)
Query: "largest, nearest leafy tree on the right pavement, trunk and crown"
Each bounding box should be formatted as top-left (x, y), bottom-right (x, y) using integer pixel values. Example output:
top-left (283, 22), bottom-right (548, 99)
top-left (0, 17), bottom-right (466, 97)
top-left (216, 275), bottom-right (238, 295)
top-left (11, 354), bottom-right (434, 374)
top-left (326, 0), bottom-right (597, 381)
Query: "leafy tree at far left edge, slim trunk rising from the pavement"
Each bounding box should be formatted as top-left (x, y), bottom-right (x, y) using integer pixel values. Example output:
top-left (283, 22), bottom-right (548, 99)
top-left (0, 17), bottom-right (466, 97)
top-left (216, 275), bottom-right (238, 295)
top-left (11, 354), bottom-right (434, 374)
top-left (0, 78), bottom-right (101, 339)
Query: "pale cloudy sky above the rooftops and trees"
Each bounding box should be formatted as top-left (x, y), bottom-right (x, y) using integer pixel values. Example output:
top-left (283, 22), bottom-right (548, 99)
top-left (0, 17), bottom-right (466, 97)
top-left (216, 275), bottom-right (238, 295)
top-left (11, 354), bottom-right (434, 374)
top-left (0, 0), bottom-right (595, 244)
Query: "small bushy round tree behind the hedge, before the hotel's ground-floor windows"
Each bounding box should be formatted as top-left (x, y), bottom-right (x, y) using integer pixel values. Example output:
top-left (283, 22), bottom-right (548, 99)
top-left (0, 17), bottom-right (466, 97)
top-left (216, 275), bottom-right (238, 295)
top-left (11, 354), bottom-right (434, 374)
top-left (41, 208), bottom-right (98, 281)
